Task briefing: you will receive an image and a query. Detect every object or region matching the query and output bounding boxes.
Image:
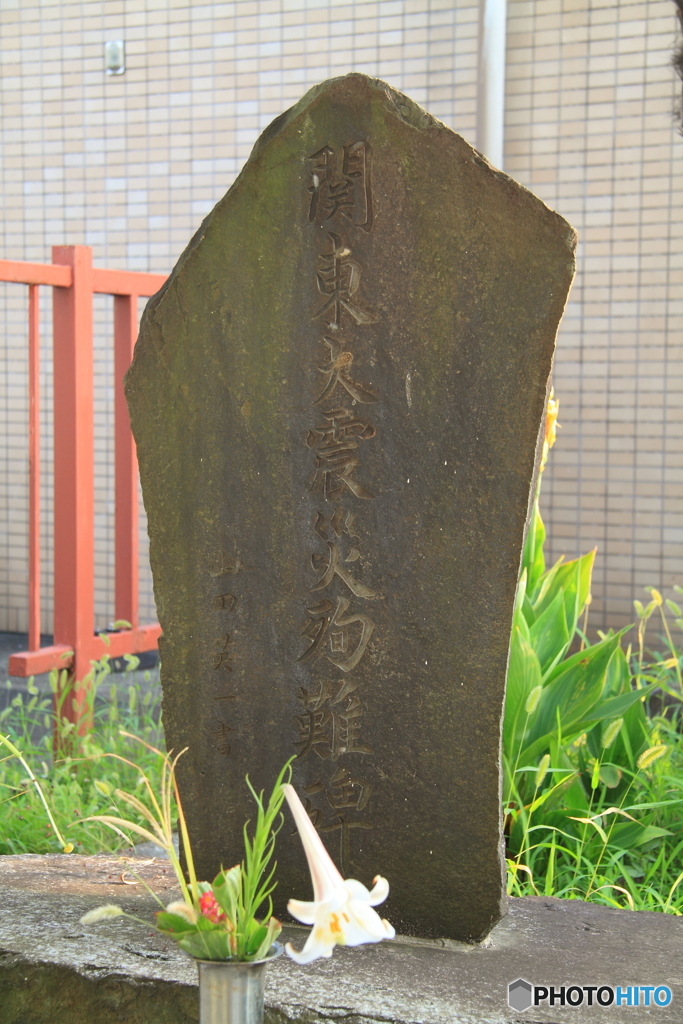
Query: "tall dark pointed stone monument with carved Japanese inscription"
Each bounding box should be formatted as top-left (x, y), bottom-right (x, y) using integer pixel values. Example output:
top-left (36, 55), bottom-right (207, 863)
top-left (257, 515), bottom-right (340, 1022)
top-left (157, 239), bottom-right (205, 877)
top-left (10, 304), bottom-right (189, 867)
top-left (127, 75), bottom-right (575, 940)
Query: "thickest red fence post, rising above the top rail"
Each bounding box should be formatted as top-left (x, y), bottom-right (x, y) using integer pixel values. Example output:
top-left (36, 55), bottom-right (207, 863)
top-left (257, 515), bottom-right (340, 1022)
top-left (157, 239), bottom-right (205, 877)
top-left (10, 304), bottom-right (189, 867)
top-left (52, 246), bottom-right (94, 733)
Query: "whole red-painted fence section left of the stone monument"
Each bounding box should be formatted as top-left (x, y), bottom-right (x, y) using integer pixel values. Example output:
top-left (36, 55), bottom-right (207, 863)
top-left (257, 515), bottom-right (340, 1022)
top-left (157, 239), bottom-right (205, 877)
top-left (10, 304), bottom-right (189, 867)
top-left (0, 246), bottom-right (166, 728)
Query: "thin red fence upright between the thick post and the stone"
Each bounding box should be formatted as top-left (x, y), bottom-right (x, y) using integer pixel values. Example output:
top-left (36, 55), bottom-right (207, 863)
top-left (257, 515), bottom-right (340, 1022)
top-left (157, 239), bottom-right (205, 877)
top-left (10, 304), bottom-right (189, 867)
top-left (114, 295), bottom-right (138, 629)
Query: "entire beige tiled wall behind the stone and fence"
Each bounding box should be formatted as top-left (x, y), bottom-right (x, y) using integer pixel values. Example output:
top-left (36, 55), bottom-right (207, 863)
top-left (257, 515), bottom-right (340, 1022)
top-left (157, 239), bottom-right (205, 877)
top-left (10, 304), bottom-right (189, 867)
top-left (0, 0), bottom-right (683, 632)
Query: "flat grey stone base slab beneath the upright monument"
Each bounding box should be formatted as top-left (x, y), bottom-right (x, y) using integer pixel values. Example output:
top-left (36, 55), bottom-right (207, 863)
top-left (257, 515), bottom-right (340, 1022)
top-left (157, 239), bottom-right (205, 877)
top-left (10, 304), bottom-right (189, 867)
top-left (0, 855), bottom-right (683, 1024)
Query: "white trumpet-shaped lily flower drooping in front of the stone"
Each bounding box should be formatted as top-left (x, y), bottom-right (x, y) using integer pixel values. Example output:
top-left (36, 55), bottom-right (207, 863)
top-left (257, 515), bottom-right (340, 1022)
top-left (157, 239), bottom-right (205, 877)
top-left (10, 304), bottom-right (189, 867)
top-left (283, 783), bottom-right (396, 964)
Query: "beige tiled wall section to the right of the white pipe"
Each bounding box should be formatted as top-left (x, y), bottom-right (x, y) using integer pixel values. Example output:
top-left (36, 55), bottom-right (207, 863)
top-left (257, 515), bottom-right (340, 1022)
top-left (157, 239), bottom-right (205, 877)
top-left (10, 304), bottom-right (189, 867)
top-left (506, 0), bottom-right (683, 627)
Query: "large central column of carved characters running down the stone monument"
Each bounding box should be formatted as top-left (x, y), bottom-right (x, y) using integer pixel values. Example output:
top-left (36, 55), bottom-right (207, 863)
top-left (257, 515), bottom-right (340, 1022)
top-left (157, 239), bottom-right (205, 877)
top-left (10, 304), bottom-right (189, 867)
top-left (294, 141), bottom-right (382, 876)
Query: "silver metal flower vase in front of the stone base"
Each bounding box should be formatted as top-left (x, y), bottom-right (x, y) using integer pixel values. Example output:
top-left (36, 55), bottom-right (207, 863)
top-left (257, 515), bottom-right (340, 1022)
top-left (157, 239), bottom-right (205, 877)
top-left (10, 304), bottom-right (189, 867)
top-left (197, 942), bottom-right (283, 1024)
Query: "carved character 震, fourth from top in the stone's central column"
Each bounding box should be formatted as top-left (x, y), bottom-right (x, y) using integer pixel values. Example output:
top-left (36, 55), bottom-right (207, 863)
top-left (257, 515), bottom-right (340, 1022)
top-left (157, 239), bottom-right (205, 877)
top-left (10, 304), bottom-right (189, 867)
top-left (306, 409), bottom-right (377, 501)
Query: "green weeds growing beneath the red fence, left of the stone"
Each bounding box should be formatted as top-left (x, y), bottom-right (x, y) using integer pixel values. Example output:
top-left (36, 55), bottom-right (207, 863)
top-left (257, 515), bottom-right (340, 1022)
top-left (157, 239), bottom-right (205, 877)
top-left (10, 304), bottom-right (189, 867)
top-left (0, 658), bottom-right (163, 854)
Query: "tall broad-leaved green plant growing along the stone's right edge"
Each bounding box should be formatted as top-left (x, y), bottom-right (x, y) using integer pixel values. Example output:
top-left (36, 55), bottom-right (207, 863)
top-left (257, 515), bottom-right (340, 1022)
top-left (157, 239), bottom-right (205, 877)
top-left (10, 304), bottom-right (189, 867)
top-left (503, 396), bottom-right (680, 902)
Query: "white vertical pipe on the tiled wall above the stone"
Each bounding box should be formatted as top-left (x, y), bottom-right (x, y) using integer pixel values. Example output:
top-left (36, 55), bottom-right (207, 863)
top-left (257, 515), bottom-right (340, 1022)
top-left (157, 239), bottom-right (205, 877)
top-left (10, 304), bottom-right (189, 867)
top-left (477, 0), bottom-right (507, 168)
